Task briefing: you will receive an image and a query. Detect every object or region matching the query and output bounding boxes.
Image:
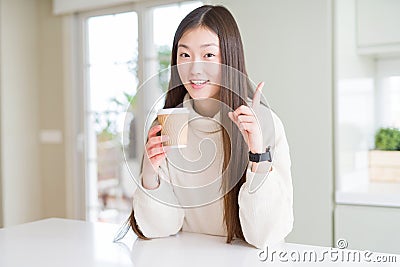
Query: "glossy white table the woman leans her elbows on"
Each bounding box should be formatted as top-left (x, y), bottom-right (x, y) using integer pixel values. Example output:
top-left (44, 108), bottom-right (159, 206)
top-left (0, 219), bottom-right (400, 267)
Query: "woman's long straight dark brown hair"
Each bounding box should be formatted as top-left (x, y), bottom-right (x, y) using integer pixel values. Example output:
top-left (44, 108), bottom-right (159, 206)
top-left (130, 5), bottom-right (260, 243)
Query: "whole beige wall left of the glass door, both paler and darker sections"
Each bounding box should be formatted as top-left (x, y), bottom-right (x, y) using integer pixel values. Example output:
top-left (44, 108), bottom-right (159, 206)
top-left (0, 0), bottom-right (66, 226)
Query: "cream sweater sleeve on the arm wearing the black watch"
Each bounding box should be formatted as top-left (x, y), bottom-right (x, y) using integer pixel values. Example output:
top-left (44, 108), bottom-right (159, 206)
top-left (238, 113), bottom-right (293, 249)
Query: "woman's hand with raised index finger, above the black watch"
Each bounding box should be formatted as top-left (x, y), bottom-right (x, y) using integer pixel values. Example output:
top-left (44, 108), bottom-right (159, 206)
top-left (228, 82), bottom-right (265, 153)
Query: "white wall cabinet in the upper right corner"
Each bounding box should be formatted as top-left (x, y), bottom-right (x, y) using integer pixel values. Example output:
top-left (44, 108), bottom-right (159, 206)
top-left (356, 0), bottom-right (400, 55)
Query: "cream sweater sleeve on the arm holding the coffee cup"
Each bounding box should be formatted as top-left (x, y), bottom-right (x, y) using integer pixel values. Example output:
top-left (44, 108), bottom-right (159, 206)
top-left (133, 160), bottom-right (184, 238)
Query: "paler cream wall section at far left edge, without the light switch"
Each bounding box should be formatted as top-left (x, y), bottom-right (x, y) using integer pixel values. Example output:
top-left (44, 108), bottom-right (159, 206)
top-left (0, 0), bottom-right (42, 226)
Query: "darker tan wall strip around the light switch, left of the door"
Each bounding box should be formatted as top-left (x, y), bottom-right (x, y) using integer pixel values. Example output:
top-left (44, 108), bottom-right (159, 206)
top-left (37, 0), bottom-right (66, 220)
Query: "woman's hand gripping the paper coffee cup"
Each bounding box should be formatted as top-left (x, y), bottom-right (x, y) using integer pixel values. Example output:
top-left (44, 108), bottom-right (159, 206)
top-left (142, 125), bottom-right (169, 189)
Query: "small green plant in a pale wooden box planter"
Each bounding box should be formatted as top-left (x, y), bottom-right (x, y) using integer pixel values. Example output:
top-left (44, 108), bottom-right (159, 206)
top-left (369, 128), bottom-right (400, 182)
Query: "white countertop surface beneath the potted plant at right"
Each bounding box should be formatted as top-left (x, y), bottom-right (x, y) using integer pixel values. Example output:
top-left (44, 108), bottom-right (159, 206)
top-left (335, 182), bottom-right (400, 207)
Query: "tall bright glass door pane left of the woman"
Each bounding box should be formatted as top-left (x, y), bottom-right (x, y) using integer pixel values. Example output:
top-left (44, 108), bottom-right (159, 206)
top-left (84, 12), bottom-right (138, 222)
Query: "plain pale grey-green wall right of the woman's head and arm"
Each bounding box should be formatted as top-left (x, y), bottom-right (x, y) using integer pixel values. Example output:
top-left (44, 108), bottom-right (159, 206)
top-left (214, 0), bottom-right (333, 246)
